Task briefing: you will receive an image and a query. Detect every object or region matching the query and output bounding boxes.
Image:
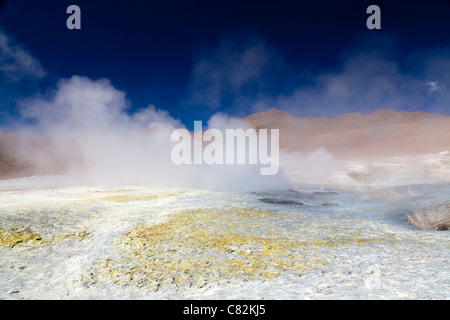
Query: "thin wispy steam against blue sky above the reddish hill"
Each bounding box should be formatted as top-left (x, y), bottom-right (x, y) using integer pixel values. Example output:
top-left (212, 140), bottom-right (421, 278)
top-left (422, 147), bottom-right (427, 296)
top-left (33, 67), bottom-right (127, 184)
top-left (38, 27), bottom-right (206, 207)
top-left (188, 36), bottom-right (450, 118)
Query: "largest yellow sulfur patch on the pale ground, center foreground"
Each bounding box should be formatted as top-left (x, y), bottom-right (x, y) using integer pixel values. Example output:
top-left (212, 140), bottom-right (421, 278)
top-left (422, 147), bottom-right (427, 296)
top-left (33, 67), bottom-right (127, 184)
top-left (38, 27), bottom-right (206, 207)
top-left (90, 208), bottom-right (348, 290)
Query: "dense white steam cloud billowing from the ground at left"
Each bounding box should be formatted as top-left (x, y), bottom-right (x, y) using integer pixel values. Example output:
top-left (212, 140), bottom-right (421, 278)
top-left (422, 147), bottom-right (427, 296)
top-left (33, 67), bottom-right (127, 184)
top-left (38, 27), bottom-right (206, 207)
top-left (16, 76), bottom-right (287, 190)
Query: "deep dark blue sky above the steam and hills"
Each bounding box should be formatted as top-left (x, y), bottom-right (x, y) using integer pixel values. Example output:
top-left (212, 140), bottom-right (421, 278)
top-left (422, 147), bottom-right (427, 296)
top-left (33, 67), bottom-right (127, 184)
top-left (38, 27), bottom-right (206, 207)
top-left (0, 0), bottom-right (450, 127)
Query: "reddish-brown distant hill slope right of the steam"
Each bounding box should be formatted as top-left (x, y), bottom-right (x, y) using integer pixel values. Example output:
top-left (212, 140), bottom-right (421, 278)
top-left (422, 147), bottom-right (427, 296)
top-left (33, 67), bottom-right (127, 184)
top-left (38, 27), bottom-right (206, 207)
top-left (245, 109), bottom-right (450, 158)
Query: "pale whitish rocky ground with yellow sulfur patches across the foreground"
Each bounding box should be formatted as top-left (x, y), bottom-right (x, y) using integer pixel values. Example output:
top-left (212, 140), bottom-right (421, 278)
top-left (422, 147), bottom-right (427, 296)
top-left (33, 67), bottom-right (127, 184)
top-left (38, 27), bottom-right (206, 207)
top-left (0, 178), bottom-right (450, 299)
